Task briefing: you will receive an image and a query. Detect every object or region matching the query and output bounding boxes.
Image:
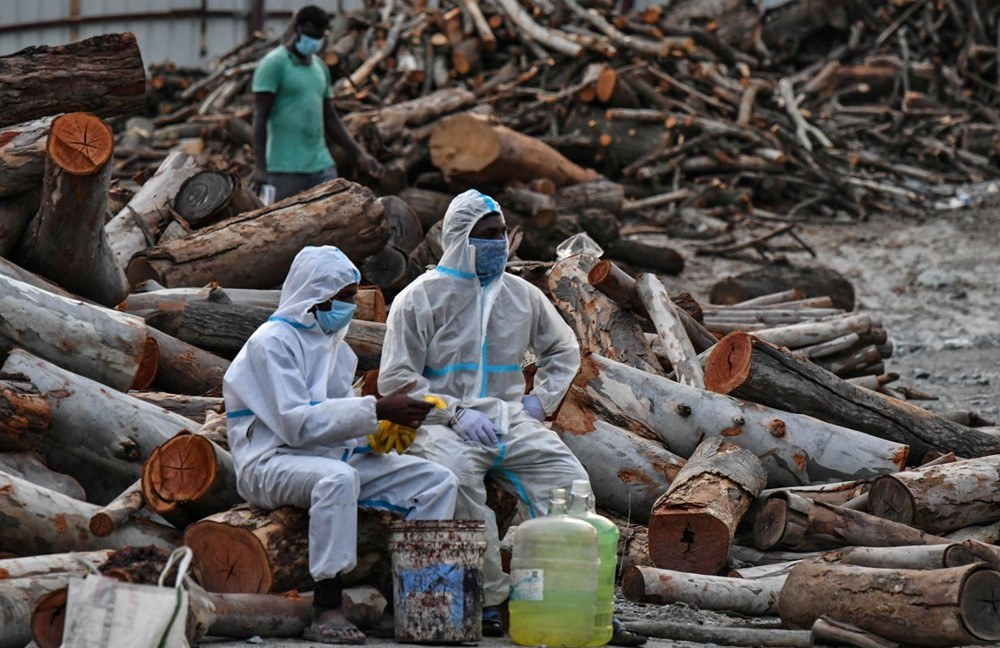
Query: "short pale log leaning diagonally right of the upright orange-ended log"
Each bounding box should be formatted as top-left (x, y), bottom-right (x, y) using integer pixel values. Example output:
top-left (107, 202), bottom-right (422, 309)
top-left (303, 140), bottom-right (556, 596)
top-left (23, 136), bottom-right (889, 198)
top-left (104, 151), bottom-right (198, 268)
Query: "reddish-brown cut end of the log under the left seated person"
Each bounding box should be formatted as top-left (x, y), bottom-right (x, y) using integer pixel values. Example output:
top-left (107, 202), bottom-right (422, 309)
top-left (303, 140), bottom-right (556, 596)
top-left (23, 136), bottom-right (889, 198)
top-left (184, 520), bottom-right (272, 594)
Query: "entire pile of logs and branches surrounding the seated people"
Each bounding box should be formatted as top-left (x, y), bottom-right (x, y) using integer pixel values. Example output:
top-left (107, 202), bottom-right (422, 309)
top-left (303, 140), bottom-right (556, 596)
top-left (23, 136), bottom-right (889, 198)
top-left (0, 0), bottom-right (1000, 648)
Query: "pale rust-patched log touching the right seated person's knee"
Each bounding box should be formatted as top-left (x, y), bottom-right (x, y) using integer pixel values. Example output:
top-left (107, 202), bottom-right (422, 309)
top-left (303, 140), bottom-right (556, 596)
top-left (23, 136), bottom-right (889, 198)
top-left (552, 389), bottom-right (685, 524)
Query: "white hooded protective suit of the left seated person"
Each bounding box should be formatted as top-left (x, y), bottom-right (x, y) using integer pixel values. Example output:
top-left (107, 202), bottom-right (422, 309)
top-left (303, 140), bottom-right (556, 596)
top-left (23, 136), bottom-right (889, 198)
top-left (222, 246), bottom-right (456, 580)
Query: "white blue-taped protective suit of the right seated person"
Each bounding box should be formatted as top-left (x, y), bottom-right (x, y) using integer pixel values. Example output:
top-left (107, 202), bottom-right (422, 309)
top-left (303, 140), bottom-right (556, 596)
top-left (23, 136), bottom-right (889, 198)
top-left (378, 190), bottom-right (587, 605)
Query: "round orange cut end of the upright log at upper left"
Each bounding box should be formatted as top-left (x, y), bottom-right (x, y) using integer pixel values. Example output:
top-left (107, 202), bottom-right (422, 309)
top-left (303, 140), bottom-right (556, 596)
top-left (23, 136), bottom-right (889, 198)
top-left (47, 112), bottom-right (115, 175)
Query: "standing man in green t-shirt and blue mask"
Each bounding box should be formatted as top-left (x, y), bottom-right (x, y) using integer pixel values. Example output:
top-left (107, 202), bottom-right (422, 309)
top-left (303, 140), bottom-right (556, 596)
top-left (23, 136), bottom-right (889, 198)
top-left (253, 5), bottom-right (382, 200)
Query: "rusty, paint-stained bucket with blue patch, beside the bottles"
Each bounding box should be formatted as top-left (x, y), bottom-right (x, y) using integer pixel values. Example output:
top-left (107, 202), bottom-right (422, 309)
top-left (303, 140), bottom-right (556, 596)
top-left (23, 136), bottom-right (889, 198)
top-left (389, 520), bottom-right (486, 643)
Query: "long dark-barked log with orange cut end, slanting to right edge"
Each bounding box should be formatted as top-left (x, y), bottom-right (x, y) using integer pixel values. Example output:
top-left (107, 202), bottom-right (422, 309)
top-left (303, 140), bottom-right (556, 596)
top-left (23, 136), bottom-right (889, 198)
top-left (705, 332), bottom-right (1000, 460)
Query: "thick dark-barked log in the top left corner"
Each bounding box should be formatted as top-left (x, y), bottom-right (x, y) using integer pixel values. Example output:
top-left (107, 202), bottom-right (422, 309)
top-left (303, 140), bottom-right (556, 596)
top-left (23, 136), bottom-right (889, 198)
top-left (0, 33), bottom-right (146, 126)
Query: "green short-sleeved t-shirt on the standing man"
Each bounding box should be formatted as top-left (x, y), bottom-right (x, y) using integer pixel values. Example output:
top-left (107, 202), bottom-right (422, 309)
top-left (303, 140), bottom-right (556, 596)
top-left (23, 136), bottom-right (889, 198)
top-left (252, 45), bottom-right (333, 173)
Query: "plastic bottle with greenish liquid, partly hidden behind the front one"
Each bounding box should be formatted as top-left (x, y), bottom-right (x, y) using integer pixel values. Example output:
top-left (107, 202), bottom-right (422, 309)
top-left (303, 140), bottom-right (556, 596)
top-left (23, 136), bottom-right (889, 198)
top-left (569, 479), bottom-right (618, 646)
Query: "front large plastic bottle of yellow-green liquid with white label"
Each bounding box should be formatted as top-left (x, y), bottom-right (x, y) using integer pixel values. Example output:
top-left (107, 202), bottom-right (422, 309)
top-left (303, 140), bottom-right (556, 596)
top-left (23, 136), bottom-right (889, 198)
top-left (510, 488), bottom-right (601, 648)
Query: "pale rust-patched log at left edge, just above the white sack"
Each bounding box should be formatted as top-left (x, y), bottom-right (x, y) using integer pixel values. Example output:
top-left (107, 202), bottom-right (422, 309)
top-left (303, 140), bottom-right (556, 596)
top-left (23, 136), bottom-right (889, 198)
top-left (0, 472), bottom-right (179, 556)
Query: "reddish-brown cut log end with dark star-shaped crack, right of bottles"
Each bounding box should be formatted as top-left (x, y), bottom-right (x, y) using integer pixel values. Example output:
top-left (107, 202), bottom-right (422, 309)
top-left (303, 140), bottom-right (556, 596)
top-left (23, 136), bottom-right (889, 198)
top-left (649, 512), bottom-right (730, 574)
